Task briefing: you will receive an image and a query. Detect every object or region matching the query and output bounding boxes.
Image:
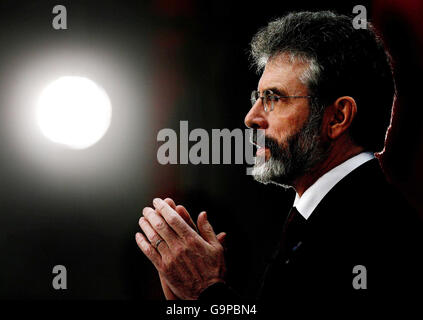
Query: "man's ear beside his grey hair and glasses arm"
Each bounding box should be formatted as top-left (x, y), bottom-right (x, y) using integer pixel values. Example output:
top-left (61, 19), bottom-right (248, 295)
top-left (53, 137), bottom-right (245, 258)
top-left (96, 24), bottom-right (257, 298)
top-left (327, 96), bottom-right (357, 140)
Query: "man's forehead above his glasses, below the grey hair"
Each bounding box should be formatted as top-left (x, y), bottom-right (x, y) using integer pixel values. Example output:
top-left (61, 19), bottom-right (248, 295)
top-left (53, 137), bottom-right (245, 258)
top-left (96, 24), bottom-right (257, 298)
top-left (258, 54), bottom-right (308, 95)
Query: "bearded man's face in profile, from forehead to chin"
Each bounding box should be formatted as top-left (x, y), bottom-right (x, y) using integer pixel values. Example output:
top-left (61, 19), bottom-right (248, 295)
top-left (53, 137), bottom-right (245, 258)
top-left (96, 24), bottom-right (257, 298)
top-left (245, 55), bottom-right (323, 186)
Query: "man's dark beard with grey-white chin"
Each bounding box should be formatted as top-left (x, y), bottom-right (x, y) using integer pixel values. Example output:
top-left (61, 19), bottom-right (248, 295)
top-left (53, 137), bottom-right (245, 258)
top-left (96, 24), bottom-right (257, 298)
top-left (252, 115), bottom-right (328, 188)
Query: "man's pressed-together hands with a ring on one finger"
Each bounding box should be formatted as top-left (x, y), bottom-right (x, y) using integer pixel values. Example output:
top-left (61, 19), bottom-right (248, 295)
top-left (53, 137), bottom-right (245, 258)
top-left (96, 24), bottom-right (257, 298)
top-left (135, 198), bottom-right (226, 300)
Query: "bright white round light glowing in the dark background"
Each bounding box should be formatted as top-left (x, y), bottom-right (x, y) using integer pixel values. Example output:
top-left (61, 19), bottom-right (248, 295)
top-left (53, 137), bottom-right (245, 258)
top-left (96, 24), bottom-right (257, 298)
top-left (36, 76), bottom-right (112, 149)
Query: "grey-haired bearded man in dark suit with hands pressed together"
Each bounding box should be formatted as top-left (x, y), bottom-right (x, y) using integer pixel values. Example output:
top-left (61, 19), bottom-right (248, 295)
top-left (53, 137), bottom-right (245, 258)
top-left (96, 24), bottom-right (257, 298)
top-left (136, 11), bottom-right (421, 299)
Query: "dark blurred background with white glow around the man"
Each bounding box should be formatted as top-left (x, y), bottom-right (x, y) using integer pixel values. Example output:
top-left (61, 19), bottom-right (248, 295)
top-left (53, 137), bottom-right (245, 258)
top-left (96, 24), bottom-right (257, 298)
top-left (0, 0), bottom-right (423, 299)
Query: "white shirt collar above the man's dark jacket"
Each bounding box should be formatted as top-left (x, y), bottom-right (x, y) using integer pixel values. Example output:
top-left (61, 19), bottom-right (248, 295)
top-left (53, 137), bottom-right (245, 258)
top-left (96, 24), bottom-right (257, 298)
top-left (294, 152), bottom-right (375, 220)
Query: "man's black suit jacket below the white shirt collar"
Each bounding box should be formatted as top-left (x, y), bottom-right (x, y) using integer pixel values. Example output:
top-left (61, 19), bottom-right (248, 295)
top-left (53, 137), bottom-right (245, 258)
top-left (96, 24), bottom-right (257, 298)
top-left (200, 159), bottom-right (423, 301)
